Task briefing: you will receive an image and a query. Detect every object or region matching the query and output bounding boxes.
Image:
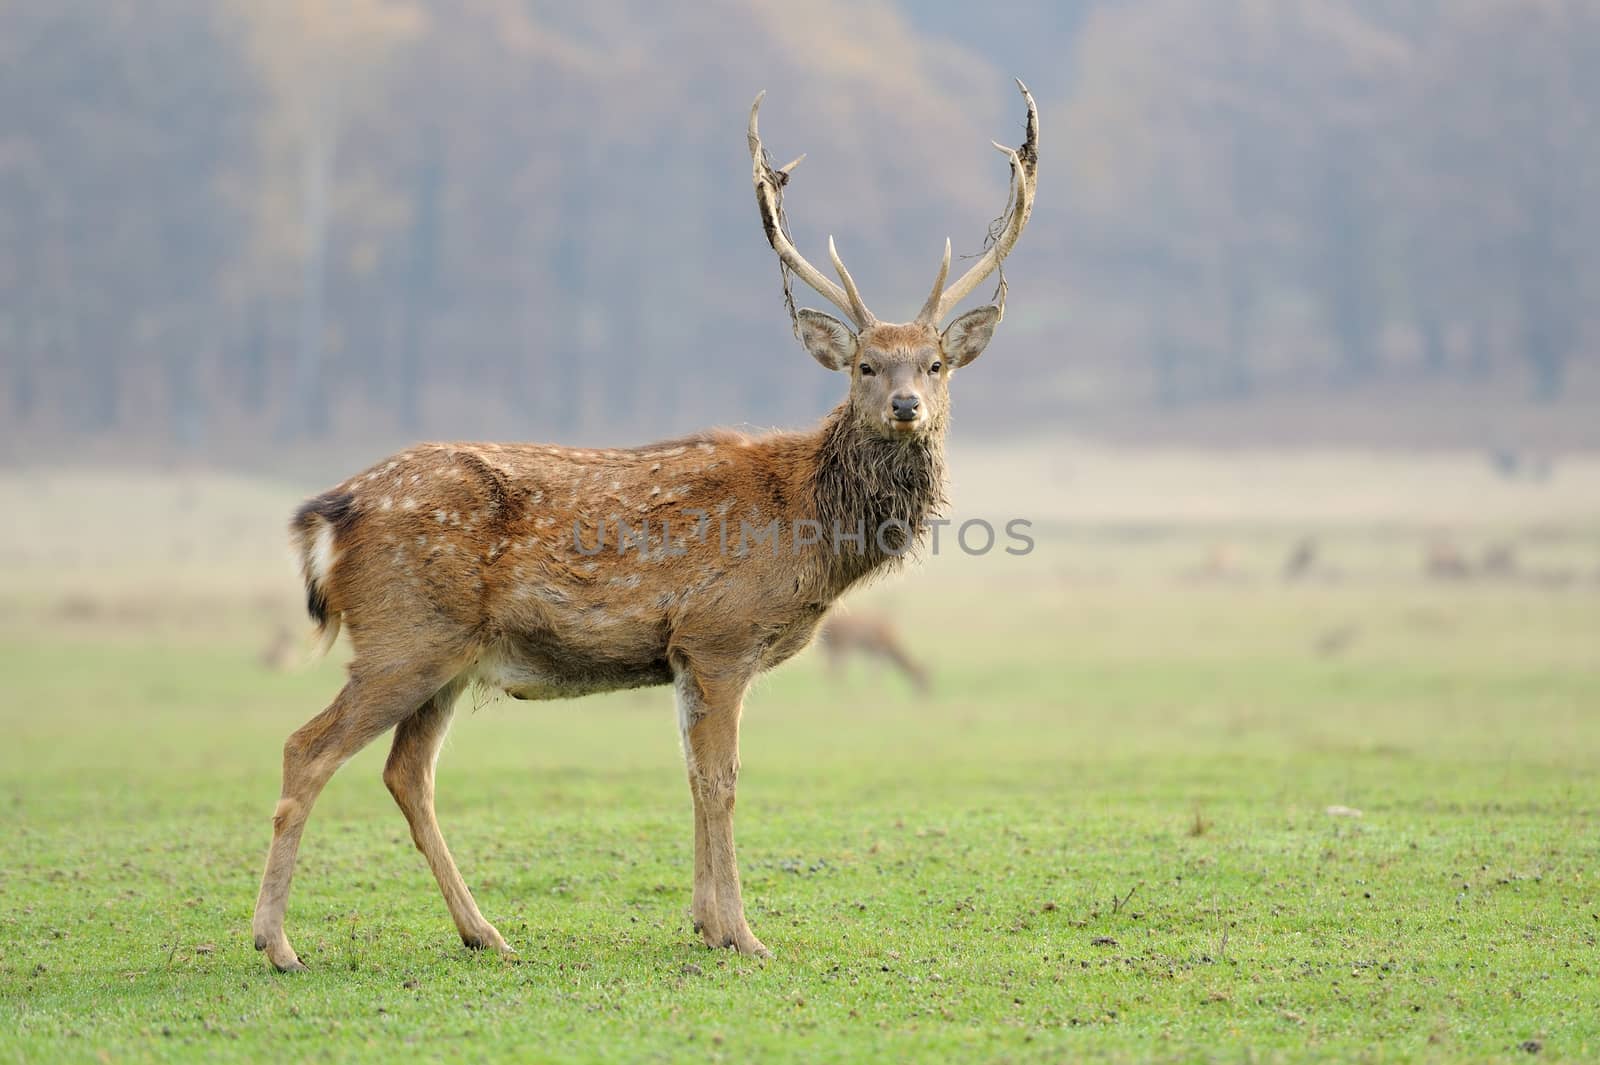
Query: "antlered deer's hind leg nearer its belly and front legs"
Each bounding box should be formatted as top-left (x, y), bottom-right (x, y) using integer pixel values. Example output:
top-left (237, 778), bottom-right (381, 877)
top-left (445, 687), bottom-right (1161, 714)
top-left (384, 683), bottom-right (510, 953)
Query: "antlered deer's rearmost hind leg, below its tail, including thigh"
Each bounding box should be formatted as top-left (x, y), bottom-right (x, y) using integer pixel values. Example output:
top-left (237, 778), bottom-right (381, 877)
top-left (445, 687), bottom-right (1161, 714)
top-left (251, 656), bottom-right (459, 972)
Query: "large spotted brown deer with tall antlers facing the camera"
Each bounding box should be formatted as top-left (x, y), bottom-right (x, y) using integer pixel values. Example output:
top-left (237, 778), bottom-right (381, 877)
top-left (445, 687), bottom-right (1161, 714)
top-left (251, 82), bottom-right (1038, 972)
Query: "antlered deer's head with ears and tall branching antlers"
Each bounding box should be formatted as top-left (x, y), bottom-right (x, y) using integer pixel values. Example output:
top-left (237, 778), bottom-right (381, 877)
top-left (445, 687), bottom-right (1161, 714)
top-left (749, 82), bottom-right (1038, 438)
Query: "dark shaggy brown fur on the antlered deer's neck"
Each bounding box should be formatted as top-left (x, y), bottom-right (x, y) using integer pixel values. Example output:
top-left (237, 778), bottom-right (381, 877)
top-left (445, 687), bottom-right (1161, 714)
top-left (810, 403), bottom-right (946, 595)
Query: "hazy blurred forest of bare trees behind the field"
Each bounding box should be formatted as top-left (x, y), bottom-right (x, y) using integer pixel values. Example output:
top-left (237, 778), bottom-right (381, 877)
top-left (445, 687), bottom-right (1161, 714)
top-left (0, 0), bottom-right (1600, 462)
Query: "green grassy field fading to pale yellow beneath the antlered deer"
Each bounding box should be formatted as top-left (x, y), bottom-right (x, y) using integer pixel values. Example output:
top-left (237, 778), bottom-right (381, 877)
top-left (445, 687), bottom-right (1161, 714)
top-left (0, 470), bottom-right (1600, 1062)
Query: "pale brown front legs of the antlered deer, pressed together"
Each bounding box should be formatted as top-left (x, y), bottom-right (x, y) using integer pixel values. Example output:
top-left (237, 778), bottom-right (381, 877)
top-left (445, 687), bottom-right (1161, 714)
top-left (678, 673), bottom-right (771, 958)
